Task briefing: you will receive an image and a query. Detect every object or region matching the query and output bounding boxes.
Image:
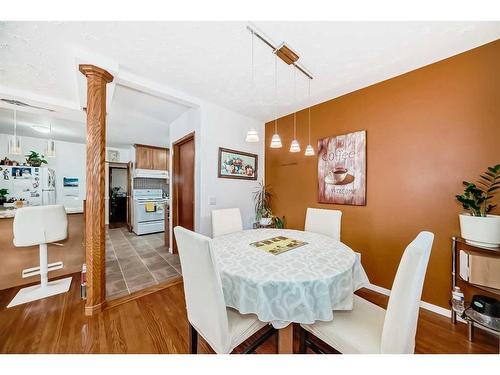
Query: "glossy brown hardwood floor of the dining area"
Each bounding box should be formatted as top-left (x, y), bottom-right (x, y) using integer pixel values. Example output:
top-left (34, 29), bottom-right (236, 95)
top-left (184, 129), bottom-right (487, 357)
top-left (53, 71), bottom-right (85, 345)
top-left (0, 274), bottom-right (498, 353)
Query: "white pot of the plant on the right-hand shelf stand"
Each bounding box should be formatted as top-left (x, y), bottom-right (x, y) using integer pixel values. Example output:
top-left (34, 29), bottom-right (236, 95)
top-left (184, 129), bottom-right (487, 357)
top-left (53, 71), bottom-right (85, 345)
top-left (460, 214), bottom-right (500, 249)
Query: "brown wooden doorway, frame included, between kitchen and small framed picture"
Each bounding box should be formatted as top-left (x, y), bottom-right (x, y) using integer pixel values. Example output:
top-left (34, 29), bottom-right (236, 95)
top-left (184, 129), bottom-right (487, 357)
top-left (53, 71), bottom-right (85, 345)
top-left (172, 132), bottom-right (195, 254)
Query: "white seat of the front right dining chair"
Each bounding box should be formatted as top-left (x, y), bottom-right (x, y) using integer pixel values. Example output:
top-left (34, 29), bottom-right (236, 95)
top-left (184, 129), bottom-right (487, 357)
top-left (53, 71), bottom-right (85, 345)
top-left (302, 295), bottom-right (385, 354)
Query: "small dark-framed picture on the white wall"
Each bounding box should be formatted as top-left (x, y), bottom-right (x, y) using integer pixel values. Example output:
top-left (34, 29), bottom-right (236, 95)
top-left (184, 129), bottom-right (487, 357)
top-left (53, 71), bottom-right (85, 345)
top-left (218, 147), bottom-right (258, 180)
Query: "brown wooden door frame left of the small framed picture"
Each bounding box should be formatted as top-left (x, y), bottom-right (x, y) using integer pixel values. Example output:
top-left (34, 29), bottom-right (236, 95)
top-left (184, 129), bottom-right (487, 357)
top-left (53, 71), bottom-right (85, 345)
top-left (170, 132), bottom-right (196, 254)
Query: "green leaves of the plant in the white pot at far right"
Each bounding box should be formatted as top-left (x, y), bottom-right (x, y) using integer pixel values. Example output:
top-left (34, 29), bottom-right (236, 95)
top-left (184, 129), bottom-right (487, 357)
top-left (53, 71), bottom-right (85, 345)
top-left (456, 164), bottom-right (500, 217)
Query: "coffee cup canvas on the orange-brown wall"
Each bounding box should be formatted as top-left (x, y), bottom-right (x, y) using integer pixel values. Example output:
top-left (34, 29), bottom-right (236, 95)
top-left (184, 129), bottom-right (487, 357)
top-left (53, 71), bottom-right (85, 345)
top-left (318, 130), bottom-right (366, 206)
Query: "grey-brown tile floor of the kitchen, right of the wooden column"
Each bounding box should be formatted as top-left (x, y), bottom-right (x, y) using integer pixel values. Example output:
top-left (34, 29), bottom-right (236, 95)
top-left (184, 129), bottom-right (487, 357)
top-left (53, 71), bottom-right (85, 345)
top-left (106, 228), bottom-right (181, 299)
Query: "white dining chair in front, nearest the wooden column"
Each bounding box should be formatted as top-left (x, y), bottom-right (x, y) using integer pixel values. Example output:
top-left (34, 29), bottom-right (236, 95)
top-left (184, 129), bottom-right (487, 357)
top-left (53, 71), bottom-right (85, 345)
top-left (174, 226), bottom-right (276, 354)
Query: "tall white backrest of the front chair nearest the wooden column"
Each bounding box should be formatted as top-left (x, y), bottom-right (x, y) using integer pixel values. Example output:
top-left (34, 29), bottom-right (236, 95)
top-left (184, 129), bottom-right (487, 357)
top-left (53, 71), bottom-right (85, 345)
top-left (174, 226), bottom-right (230, 353)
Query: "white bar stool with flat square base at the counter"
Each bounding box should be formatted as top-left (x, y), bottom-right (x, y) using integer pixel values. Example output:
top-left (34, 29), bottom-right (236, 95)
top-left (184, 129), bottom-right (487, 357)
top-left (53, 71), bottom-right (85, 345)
top-left (7, 205), bottom-right (71, 307)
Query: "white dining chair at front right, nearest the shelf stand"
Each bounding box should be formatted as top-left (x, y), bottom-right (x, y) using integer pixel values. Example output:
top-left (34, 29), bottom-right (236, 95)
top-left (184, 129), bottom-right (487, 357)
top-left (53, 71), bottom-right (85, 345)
top-left (300, 232), bottom-right (434, 354)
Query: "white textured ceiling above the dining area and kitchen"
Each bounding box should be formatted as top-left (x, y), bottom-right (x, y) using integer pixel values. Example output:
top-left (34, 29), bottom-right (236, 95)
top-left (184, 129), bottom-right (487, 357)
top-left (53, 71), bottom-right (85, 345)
top-left (0, 22), bottom-right (500, 144)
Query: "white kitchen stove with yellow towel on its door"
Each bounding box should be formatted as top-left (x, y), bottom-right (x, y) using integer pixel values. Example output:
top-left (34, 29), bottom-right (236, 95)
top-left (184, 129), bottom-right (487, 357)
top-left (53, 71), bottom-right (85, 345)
top-left (132, 189), bottom-right (168, 235)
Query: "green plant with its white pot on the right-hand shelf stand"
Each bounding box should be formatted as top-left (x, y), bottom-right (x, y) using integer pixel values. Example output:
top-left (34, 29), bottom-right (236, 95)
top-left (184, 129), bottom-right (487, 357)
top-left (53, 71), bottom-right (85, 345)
top-left (456, 164), bottom-right (500, 248)
